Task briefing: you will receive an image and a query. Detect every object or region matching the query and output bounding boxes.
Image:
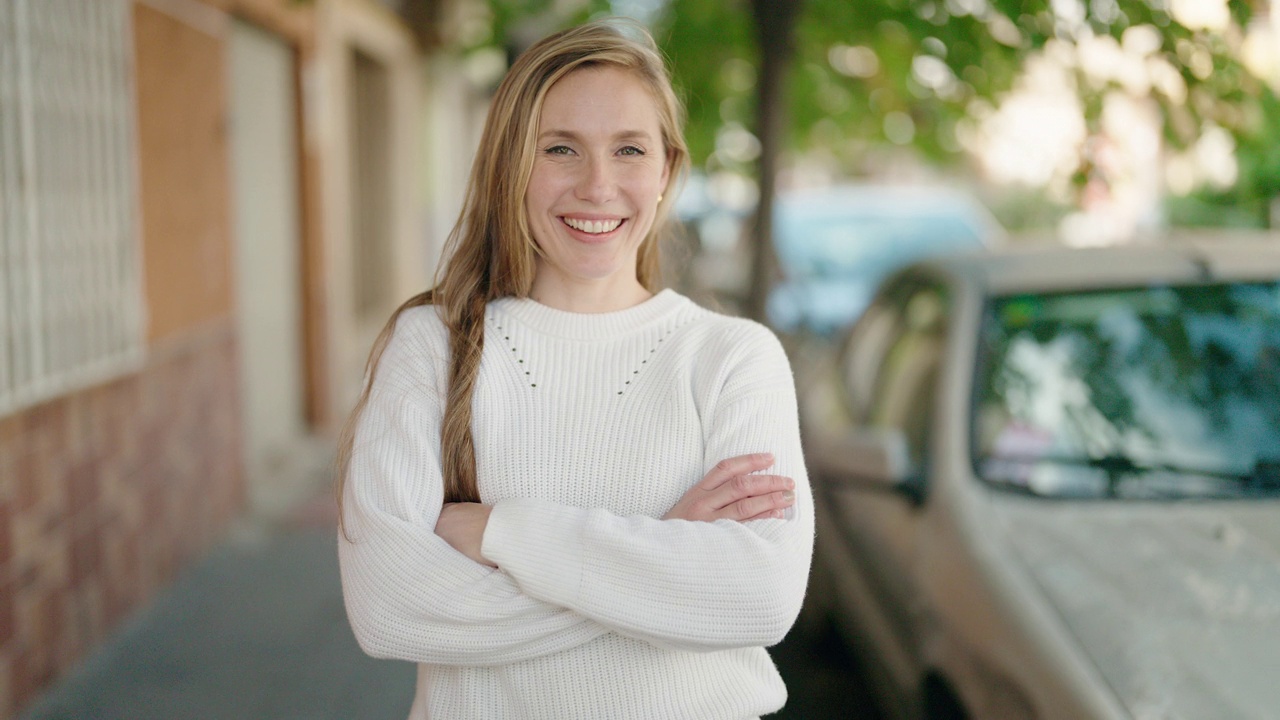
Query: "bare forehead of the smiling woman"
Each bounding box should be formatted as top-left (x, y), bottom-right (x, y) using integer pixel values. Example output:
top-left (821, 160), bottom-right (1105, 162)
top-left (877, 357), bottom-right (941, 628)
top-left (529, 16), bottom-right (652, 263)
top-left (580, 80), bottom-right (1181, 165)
top-left (539, 65), bottom-right (659, 132)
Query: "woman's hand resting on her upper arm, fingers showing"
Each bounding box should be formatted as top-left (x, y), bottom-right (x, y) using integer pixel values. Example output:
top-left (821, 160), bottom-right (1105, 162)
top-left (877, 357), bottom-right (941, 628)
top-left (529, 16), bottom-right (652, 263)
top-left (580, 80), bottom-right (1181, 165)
top-left (662, 452), bottom-right (796, 521)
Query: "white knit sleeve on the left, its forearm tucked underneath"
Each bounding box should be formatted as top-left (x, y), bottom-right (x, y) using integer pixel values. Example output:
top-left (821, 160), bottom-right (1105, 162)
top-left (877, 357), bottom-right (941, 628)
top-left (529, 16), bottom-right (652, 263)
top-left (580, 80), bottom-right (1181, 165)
top-left (338, 322), bottom-right (608, 665)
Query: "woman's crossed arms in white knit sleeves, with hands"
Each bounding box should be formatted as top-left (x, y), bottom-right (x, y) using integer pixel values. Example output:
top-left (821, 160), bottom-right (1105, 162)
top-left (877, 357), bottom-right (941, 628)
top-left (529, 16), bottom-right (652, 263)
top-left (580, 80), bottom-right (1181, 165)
top-left (339, 326), bottom-right (813, 665)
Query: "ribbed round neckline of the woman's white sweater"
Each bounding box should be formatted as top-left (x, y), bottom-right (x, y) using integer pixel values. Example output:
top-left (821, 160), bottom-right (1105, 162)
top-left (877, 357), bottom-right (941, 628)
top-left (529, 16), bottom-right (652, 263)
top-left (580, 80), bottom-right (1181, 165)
top-left (492, 288), bottom-right (685, 340)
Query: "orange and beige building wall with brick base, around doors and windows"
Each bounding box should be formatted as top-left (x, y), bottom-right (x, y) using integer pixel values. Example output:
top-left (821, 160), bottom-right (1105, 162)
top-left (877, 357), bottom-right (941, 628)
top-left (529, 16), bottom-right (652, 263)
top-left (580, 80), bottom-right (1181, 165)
top-left (0, 0), bottom-right (450, 719)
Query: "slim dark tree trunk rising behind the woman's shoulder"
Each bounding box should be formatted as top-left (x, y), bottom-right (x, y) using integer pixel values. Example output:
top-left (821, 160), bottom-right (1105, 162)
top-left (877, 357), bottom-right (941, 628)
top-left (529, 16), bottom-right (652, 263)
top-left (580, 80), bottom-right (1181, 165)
top-left (745, 0), bottom-right (801, 323)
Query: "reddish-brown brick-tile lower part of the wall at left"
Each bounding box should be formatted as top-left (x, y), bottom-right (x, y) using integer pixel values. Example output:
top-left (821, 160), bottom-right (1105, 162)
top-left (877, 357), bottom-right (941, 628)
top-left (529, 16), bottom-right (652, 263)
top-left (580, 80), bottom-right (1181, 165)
top-left (0, 319), bottom-right (244, 717)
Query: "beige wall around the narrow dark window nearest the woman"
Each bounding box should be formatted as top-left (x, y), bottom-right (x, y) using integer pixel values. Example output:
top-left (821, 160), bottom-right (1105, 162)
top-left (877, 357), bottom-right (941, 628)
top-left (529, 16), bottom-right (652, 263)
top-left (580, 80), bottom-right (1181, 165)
top-left (315, 0), bottom-right (427, 420)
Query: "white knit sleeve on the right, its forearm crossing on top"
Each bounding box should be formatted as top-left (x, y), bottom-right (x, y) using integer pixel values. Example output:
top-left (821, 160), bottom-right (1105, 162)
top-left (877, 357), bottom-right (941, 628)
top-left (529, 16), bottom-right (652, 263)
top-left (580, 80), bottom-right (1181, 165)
top-left (483, 325), bottom-right (813, 651)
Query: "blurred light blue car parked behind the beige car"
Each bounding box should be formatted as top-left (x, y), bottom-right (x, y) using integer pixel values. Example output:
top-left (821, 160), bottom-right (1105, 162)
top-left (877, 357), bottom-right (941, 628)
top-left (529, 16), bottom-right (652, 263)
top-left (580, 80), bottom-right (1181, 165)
top-left (768, 184), bottom-right (1005, 336)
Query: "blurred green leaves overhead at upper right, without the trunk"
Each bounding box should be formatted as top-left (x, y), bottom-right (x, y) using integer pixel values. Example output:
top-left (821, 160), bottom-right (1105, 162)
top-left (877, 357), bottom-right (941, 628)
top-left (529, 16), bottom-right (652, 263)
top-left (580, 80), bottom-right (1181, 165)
top-left (658, 0), bottom-right (1275, 197)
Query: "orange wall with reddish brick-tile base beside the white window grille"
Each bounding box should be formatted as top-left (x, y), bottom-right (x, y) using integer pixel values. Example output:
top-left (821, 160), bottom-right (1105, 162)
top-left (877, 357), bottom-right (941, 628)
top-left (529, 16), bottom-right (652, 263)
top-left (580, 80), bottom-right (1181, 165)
top-left (0, 0), bottom-right (254, 717)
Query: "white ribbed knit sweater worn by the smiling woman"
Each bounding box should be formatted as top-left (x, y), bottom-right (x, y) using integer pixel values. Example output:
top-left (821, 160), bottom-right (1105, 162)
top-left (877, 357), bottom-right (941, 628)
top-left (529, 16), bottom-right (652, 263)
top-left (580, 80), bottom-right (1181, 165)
top-left (339, 291), bottom-right (813, 720)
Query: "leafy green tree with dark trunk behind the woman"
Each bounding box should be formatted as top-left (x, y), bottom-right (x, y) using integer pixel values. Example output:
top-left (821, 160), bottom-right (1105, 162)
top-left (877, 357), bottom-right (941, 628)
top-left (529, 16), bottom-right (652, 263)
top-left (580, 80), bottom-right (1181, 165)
top-left (408, 0), bottom-right (1280, 319)
